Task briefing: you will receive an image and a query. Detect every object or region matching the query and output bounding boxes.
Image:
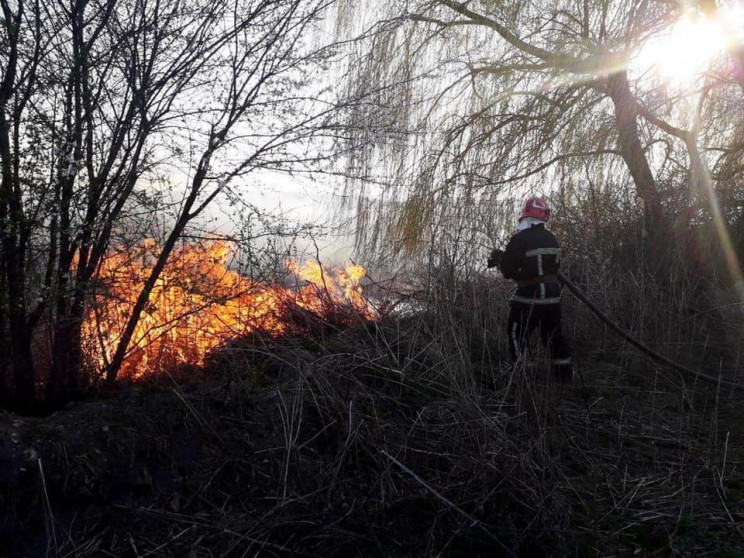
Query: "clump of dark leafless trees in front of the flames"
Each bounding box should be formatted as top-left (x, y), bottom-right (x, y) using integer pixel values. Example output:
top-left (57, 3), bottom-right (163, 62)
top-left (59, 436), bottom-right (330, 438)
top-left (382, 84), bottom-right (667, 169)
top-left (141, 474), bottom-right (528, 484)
top-left (0, 0), bottom-right (331, 408)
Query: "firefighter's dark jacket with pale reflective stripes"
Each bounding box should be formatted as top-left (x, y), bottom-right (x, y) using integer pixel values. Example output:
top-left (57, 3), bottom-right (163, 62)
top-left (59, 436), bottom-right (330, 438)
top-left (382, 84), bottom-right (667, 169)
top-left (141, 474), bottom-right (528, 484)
top-left (499, 225), bottom-right (561, 304)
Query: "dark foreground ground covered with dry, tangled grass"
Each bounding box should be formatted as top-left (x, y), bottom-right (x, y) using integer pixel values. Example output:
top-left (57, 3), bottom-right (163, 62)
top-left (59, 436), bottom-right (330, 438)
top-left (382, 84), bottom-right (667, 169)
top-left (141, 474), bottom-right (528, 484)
top-left (0, 327), bottom-right (744, 558)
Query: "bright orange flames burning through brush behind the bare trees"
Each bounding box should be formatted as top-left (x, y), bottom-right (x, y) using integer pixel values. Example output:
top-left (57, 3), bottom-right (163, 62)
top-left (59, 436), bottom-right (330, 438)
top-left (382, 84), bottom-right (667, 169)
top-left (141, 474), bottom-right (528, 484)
top-left (83, 241), bottom-right (373, 379)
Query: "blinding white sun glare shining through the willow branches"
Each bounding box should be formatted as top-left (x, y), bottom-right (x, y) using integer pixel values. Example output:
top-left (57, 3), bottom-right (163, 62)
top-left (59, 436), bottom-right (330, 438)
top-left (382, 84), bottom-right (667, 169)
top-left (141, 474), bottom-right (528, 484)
top-left (633, 5), bottom-right (744, 87)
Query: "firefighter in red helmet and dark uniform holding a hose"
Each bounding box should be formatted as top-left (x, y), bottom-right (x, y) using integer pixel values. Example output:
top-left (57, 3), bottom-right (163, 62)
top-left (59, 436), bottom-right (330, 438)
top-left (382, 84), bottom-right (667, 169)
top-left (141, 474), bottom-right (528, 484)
top-left (488, 197), bottom-right (573, 383)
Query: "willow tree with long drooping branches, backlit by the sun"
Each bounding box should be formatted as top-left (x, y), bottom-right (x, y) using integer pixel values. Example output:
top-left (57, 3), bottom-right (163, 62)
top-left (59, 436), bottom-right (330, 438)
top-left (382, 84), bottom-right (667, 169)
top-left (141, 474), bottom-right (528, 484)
top-left (338, 0), bottom-right (744, 274)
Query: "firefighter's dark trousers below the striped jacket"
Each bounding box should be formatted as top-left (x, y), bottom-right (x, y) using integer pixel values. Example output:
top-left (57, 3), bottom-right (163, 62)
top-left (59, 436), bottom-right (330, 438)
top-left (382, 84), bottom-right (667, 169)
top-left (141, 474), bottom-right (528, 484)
top-left (507, 301), bottom-right (573, 382)
